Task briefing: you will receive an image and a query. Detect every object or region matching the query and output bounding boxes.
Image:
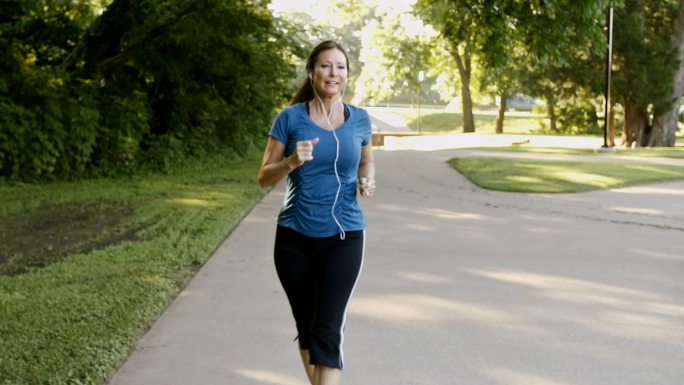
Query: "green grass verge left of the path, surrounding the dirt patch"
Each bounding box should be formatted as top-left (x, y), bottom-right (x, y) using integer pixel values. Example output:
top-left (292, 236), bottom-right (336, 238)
top-left (0, 152), bottom-right (264, 385)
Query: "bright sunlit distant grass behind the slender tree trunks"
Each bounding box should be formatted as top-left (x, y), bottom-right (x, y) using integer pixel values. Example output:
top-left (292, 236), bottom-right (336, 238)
top-left (396, 109), bottom-right (545, 134)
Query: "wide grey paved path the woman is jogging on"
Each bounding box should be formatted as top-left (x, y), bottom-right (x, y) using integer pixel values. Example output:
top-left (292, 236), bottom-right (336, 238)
top-left (111, 150), bottom-right (684, 385)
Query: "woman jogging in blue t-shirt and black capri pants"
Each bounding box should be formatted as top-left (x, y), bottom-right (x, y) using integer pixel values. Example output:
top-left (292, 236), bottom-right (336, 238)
top-left (259, 41), bottom-right (375, 385)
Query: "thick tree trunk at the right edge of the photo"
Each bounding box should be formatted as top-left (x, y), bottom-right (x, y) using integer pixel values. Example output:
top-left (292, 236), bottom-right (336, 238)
top-left (647, 0), bottom-right (684, 147)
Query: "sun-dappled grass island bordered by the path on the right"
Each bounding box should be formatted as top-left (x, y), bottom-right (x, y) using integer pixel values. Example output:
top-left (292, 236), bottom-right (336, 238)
top-left (449, 158), bottom-right (684, 193)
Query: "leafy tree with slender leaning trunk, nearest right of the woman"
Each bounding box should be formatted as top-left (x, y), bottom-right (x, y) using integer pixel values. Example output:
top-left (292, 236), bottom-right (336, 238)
top-left (417, 0), bottom-right (607, 132)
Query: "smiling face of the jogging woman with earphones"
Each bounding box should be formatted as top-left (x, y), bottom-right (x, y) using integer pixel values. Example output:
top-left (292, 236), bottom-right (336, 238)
top-left (311, 48), bottom-right (347, 97)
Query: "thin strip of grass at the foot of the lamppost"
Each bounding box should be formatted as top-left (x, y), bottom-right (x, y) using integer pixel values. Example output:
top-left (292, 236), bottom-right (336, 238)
top-left (464, 145), bottom-right (684, 158)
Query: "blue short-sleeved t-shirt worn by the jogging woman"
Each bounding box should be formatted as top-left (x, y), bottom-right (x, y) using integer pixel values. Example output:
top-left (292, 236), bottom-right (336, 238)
top-left (270, 103), bottom-right (371, 237)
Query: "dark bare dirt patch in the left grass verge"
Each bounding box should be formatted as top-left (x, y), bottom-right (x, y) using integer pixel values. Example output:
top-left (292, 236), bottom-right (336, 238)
top-left (0, 203), bottom-right (143, 275)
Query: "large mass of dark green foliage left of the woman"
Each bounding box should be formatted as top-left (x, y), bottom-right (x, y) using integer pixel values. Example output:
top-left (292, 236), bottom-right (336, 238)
top-left (0, 0), bottom-right (302, 180)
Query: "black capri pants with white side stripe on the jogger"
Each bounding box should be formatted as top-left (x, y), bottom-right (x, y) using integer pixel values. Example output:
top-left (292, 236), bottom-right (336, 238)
top-left (274, 226), bottom-right (365, 369)
